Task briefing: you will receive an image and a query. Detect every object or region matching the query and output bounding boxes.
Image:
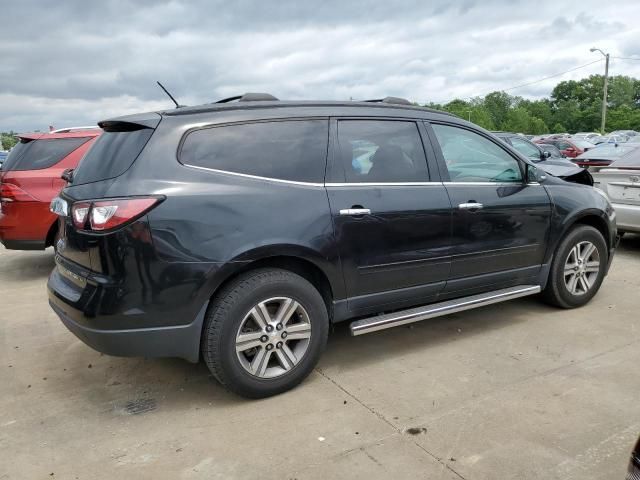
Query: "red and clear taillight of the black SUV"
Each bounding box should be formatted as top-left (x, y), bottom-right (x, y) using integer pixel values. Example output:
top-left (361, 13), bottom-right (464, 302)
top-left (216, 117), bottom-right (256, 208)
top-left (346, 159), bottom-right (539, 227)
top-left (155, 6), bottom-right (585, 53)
top-left (71, 197), bottom-right (161, 232)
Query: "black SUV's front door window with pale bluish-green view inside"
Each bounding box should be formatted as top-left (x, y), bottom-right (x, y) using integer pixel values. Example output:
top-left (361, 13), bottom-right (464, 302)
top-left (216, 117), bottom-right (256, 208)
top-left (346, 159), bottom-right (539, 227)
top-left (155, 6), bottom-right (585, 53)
top-left (432, 124), bottom-right (522, 182)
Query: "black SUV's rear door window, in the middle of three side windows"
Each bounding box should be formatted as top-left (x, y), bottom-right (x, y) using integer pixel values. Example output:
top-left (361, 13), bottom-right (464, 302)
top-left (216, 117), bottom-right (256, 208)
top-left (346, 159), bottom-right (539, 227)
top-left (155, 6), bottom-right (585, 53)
top-left (338, 120), bottom-right (429, 183)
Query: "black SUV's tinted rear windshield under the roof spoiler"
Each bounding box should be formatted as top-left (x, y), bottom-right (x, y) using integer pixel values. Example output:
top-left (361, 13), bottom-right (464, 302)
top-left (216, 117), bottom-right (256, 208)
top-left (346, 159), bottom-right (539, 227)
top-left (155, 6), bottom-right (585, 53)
top-left (73, 128), bottom-right (153, 185)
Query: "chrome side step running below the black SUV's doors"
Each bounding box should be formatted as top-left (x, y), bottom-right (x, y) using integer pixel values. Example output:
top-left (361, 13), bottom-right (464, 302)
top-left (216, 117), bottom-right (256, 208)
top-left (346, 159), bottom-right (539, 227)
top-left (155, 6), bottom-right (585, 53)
top-left (349, 285), bottom-right (542, 336)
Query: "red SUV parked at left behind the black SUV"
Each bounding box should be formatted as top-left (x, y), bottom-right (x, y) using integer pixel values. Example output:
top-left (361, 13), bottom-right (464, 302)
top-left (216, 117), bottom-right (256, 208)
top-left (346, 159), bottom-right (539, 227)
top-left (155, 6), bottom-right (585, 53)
top-left (0, 127), bottom-right (102, 250)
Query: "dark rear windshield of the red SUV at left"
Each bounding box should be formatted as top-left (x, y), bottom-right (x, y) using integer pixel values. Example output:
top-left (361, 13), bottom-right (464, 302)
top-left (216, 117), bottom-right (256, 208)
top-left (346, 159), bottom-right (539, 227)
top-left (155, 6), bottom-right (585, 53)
top-left (2, 137), bottom-right (92, 171)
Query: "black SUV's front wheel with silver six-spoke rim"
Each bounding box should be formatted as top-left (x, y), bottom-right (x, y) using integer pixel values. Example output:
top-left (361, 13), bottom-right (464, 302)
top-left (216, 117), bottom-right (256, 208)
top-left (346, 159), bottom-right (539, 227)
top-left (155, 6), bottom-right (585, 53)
top-left (542, 225), bottom-right (609, 308)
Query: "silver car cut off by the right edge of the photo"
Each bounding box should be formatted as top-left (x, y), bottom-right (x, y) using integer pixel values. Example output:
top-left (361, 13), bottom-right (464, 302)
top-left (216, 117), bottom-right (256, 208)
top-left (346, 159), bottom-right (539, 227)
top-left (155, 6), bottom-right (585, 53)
top-left (593, 148), bottom-right (640, 233)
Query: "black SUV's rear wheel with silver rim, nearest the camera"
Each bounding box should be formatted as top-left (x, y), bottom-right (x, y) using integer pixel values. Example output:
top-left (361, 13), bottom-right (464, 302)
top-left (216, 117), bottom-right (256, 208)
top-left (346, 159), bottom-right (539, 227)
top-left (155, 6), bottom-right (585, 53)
top-left (201, 268), bottom-right (329, 398)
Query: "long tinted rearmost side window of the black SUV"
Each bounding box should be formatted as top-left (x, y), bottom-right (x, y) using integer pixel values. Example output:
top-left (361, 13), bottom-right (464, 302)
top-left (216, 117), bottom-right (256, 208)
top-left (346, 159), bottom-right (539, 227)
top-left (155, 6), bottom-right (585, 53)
top-left (180, 120), bottom-right (329, 182)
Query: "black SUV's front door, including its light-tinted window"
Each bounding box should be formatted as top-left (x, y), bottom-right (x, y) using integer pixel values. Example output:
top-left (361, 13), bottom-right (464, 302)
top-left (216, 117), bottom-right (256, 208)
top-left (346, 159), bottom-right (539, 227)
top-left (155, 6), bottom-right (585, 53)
top-left (424, 123), bottom-right (551, 296)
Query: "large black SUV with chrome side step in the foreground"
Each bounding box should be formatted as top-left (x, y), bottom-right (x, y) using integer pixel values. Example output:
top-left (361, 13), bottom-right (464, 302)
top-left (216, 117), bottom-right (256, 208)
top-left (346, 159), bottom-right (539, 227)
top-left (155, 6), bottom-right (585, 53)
top-left (48, 94), bottom-right (616, 397)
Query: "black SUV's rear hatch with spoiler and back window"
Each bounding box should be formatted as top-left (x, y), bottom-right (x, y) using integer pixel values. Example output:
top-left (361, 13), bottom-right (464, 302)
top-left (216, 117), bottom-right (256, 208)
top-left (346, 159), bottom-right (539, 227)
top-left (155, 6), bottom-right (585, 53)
top-left (51, 113), bottom-right (161, 273)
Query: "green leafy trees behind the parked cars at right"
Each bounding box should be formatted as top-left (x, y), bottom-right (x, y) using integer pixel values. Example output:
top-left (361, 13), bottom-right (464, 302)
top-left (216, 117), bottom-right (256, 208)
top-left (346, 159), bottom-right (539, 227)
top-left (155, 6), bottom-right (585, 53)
top-left (428, 75), bottom-right (640, 135)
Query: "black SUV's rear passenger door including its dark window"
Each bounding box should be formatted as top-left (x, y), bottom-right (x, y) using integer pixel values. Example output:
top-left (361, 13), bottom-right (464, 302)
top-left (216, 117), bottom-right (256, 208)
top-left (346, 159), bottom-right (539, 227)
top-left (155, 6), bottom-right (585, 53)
top-left (326, 118), bottom-right (451, 314)
